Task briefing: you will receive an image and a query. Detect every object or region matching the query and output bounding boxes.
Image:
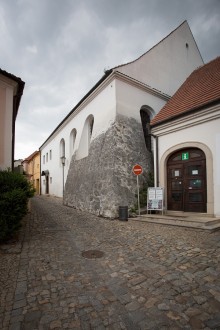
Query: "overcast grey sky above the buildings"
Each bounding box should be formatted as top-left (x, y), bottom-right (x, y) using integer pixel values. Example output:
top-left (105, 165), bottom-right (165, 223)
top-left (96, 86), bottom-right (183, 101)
top-left (0, 0), bottom-right (220, 159)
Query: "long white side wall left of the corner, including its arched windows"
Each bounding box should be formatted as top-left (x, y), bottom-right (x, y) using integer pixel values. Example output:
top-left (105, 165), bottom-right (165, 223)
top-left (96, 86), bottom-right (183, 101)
top-left (40, 80), bottom-right (116, 197)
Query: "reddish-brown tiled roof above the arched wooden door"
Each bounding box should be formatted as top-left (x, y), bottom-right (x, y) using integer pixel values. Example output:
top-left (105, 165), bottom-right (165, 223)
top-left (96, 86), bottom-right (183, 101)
top-left (151, 57), bottom-right (220, 127)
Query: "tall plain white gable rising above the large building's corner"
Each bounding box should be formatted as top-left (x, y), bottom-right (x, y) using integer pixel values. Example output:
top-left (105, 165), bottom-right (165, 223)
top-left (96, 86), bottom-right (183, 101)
top-left (113, 21), bottom-right (204, 96)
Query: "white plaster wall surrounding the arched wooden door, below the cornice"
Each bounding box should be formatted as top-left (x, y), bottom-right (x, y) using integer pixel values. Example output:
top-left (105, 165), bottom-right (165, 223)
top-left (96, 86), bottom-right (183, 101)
top-left (152, 118), bottom-right (220, 216)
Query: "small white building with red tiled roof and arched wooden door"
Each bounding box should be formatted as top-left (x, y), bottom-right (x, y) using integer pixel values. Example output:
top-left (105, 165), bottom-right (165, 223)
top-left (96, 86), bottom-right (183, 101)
top-left (151, 57), bottom-right (220, 217)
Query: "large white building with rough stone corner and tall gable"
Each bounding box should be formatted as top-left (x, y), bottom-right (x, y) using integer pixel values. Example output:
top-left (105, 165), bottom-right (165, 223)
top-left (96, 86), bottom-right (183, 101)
top-left (40, 22), bottom-right (203, 217)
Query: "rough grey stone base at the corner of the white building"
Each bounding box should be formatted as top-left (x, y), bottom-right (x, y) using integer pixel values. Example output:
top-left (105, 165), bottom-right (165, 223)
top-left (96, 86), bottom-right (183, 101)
top-left (64, 115), bottom-right (152, 218)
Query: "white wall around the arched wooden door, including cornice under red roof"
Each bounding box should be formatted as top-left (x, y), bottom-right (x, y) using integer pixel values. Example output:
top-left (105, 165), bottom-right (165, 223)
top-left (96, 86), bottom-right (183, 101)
top-left (152, 106), bottom-right (220, 217)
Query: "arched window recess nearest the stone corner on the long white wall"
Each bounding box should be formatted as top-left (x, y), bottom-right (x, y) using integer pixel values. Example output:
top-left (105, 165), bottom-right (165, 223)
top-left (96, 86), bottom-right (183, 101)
top-left (76, 115), bottom-right (94, 159)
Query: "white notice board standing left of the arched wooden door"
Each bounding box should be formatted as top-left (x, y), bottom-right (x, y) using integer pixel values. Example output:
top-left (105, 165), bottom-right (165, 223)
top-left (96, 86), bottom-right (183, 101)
top-left (147, 187), bottom-right (164, 212)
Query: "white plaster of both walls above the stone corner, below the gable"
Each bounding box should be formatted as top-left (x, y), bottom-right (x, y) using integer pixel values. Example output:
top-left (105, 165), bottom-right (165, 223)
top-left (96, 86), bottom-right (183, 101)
top-left (40, 73), bottom-right (169, 197)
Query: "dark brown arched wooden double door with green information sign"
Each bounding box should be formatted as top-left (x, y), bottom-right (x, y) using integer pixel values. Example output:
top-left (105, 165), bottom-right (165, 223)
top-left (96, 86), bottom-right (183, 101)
top-left (167, 148), bottom-right (207, 213)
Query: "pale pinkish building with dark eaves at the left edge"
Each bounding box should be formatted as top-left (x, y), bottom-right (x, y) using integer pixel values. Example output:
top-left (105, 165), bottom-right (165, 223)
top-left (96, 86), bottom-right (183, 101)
top-left (0, 69), bottom-right (25, 170)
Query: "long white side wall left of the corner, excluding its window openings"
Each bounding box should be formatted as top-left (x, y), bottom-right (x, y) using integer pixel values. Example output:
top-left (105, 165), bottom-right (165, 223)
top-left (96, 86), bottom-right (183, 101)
top-left (40, 80), bottom-right (116, 197)
